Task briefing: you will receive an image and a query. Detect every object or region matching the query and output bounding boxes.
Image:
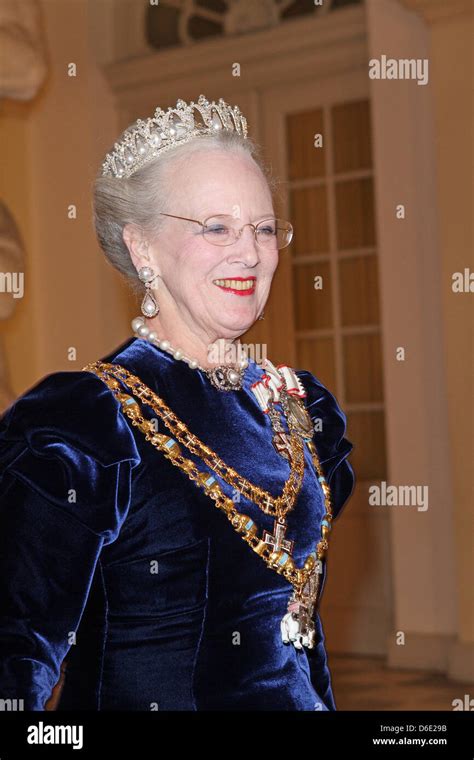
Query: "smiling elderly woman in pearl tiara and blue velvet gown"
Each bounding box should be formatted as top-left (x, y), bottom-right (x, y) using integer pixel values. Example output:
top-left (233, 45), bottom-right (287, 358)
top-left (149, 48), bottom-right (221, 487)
top-left (0, 95), bottom-right (354, 710)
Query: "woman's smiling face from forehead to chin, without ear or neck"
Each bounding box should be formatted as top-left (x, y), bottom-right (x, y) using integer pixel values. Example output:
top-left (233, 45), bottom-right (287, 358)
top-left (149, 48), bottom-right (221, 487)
top-left (143, 150), bottom-right (279, 342)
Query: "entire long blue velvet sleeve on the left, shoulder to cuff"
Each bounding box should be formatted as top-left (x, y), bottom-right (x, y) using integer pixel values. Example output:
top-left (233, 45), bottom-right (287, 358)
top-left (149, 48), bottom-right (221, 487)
top-left (0, 371), bottom-right (140, 710)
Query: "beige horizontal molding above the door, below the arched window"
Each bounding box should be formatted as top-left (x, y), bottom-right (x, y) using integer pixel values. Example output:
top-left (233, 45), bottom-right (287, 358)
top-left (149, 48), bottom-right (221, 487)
top-left (103, 6), bottom-right (367, 103)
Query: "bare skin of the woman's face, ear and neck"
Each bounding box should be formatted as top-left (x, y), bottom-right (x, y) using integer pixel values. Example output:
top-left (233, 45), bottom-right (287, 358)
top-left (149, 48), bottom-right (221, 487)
top-left (116, 144), bottom-right (280, 366)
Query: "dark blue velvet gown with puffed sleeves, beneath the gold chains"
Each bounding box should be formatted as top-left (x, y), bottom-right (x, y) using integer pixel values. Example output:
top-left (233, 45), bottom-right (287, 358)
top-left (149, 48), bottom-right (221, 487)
top-left (0, 338), bottom-right (354, 711)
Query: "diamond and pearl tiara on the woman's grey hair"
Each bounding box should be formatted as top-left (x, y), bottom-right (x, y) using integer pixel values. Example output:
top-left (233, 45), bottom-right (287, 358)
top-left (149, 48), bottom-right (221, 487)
top-left (102, 95), bottom-right (247, 179)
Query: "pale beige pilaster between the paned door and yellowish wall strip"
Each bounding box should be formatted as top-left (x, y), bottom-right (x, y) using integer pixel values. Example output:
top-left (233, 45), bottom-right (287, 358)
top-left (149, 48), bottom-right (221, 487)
top-left (367, 0), bottom-right (456, 667)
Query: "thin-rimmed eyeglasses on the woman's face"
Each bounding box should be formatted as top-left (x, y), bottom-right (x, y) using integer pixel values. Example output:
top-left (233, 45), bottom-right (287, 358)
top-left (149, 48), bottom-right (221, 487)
top-left (161, 212), bottom-right (293, 250)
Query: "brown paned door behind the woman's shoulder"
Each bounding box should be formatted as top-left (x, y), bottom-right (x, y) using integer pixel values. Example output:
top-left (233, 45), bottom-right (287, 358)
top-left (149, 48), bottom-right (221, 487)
top-left (261, 78), bottom-right (391, 654)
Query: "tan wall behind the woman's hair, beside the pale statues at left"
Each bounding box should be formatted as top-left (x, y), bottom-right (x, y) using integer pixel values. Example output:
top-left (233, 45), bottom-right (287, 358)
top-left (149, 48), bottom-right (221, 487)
top-left (0, 0), bottom-right (130, 394)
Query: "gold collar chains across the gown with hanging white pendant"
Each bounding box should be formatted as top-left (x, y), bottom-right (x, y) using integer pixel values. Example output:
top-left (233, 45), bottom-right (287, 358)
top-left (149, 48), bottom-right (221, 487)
top-left (83, 361), bottom-right (332, 649)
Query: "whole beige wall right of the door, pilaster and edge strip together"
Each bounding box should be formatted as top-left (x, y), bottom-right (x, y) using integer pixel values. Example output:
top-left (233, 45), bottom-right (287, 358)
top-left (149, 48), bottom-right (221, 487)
top-left (367, 0), bottom-right (474, 682)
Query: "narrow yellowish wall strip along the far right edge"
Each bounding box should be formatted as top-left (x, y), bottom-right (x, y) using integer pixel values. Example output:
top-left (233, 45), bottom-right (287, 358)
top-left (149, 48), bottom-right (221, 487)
top-left (430, 6), bottom-right (474, 678)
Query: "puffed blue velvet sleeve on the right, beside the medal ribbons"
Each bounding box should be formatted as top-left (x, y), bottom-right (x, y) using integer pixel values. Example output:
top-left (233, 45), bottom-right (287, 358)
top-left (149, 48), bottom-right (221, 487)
top-left (296, 370), bottom-right (355, 519)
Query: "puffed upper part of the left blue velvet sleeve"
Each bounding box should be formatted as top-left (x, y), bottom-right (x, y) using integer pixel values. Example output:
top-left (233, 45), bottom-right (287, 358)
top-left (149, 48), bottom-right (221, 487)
top-left (0, 371), bottom-right (140, 543)
